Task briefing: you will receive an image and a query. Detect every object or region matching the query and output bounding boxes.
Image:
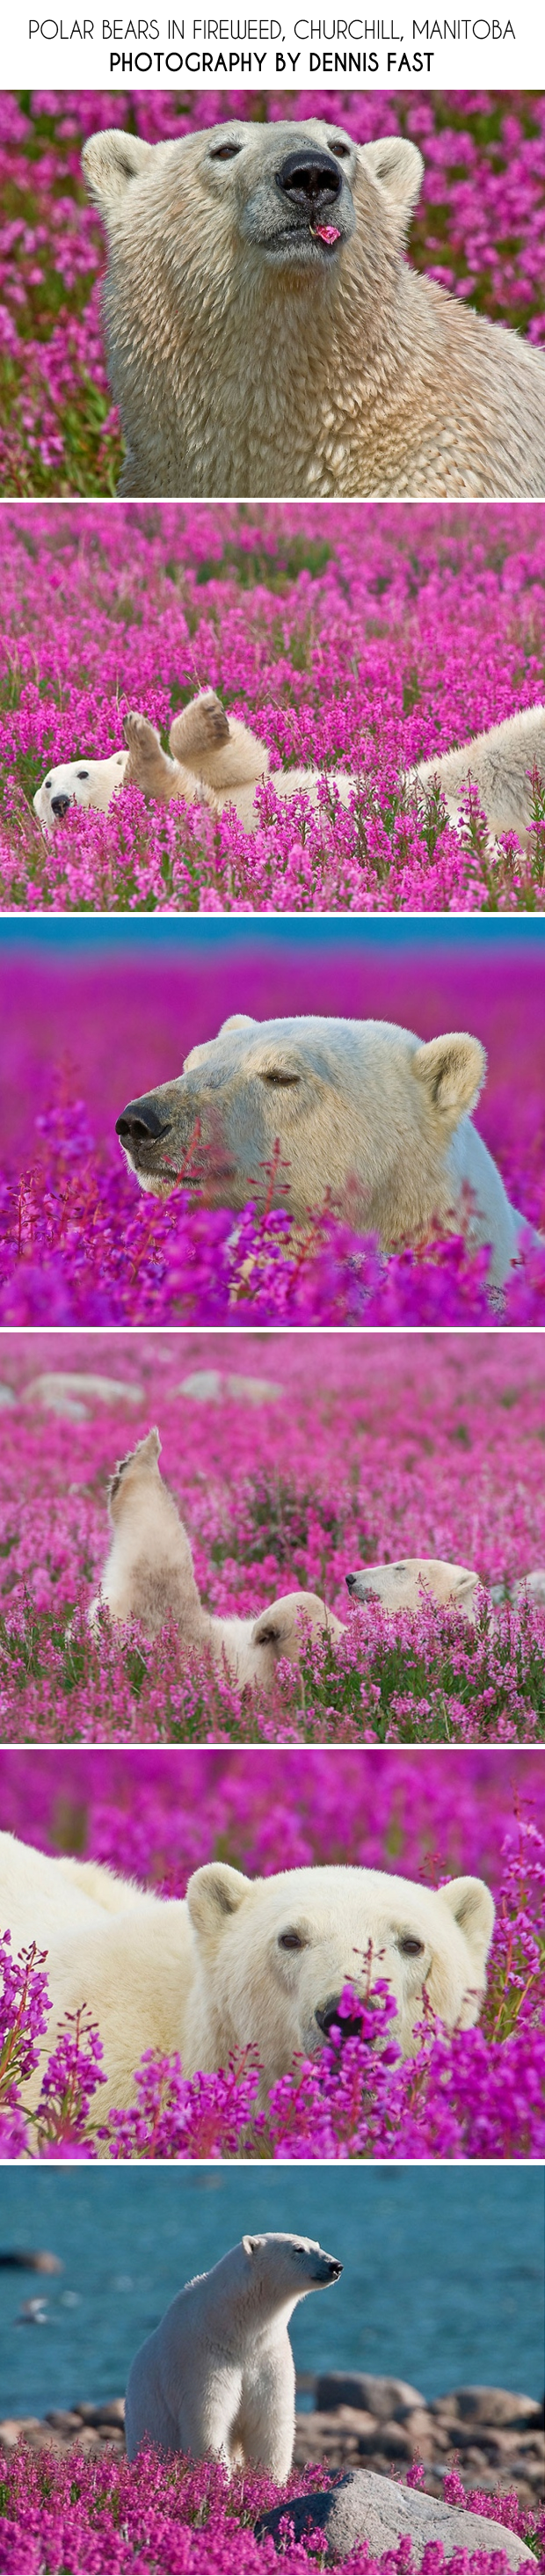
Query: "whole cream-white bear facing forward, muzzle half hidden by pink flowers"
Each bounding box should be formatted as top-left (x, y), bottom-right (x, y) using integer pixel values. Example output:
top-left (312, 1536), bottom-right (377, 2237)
top-left (0, 1834), bottom-right (494, 2118)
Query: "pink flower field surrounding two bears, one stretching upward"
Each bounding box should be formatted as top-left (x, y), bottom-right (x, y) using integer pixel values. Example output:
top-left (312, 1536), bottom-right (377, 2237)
top-left (0, 1332), bottom-right (545, 1747)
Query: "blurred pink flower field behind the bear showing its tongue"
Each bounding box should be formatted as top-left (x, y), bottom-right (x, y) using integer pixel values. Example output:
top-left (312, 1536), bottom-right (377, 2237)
top-left (0, 91), bottom-right (545, 494)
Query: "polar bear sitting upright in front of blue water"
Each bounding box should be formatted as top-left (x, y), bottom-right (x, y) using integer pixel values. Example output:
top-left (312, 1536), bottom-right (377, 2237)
top-left (126, 2236), bottom-right (342, 2485)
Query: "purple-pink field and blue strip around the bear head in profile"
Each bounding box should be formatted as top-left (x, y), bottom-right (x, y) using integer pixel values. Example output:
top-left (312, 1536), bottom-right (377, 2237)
top-left (0, 920), bottom-right (545, 1329)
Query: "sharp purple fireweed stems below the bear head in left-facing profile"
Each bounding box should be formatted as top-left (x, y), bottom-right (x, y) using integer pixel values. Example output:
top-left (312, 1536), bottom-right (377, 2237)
top-left (0, 1051), bottom-right (545, 1326)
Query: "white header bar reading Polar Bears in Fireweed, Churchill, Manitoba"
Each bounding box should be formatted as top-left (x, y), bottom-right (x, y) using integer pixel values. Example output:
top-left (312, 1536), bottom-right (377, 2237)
top-left (3, 0), bottom-right (545, 92)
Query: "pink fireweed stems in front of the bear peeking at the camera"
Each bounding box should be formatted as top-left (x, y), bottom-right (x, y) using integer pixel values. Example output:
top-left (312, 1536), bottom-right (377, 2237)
top-left (0, 1816), bottom-right (545, 2161)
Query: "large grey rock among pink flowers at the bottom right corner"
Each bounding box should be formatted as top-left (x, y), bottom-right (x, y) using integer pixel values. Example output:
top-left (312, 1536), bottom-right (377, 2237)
top-left (255, 2468), bottom-right (534, 2568)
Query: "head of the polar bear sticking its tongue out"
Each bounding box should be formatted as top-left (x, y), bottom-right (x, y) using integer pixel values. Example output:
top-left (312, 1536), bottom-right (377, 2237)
top-left (83, 116), bottom-right (422, 303)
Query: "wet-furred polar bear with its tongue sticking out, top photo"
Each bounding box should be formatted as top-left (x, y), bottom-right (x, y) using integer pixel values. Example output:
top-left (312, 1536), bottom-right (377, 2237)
top-left (83, 116), bottom-right (545, 500)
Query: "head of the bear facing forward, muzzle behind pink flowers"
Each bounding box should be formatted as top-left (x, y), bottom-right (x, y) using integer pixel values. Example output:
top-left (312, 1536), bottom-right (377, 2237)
top-left (187, 1863), bottom-right (494, 2094)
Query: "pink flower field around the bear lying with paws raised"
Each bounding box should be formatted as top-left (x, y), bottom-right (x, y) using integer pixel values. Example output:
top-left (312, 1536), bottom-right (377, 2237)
top-left (0, 497), bottom-right (545, 915)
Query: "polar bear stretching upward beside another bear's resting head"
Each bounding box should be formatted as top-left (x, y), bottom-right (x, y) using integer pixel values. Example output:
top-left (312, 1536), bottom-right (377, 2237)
top-left (87, 1425), bottom-right (345, 1692)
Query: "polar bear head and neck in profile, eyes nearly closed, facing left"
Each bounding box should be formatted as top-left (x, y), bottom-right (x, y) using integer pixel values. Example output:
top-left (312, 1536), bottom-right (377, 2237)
top-left (116, 1012), bottom-right (537, 1288)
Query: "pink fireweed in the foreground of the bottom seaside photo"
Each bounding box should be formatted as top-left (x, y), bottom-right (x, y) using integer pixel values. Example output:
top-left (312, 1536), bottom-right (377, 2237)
top-left (0, 2445), bottom-right (545, 2576)
